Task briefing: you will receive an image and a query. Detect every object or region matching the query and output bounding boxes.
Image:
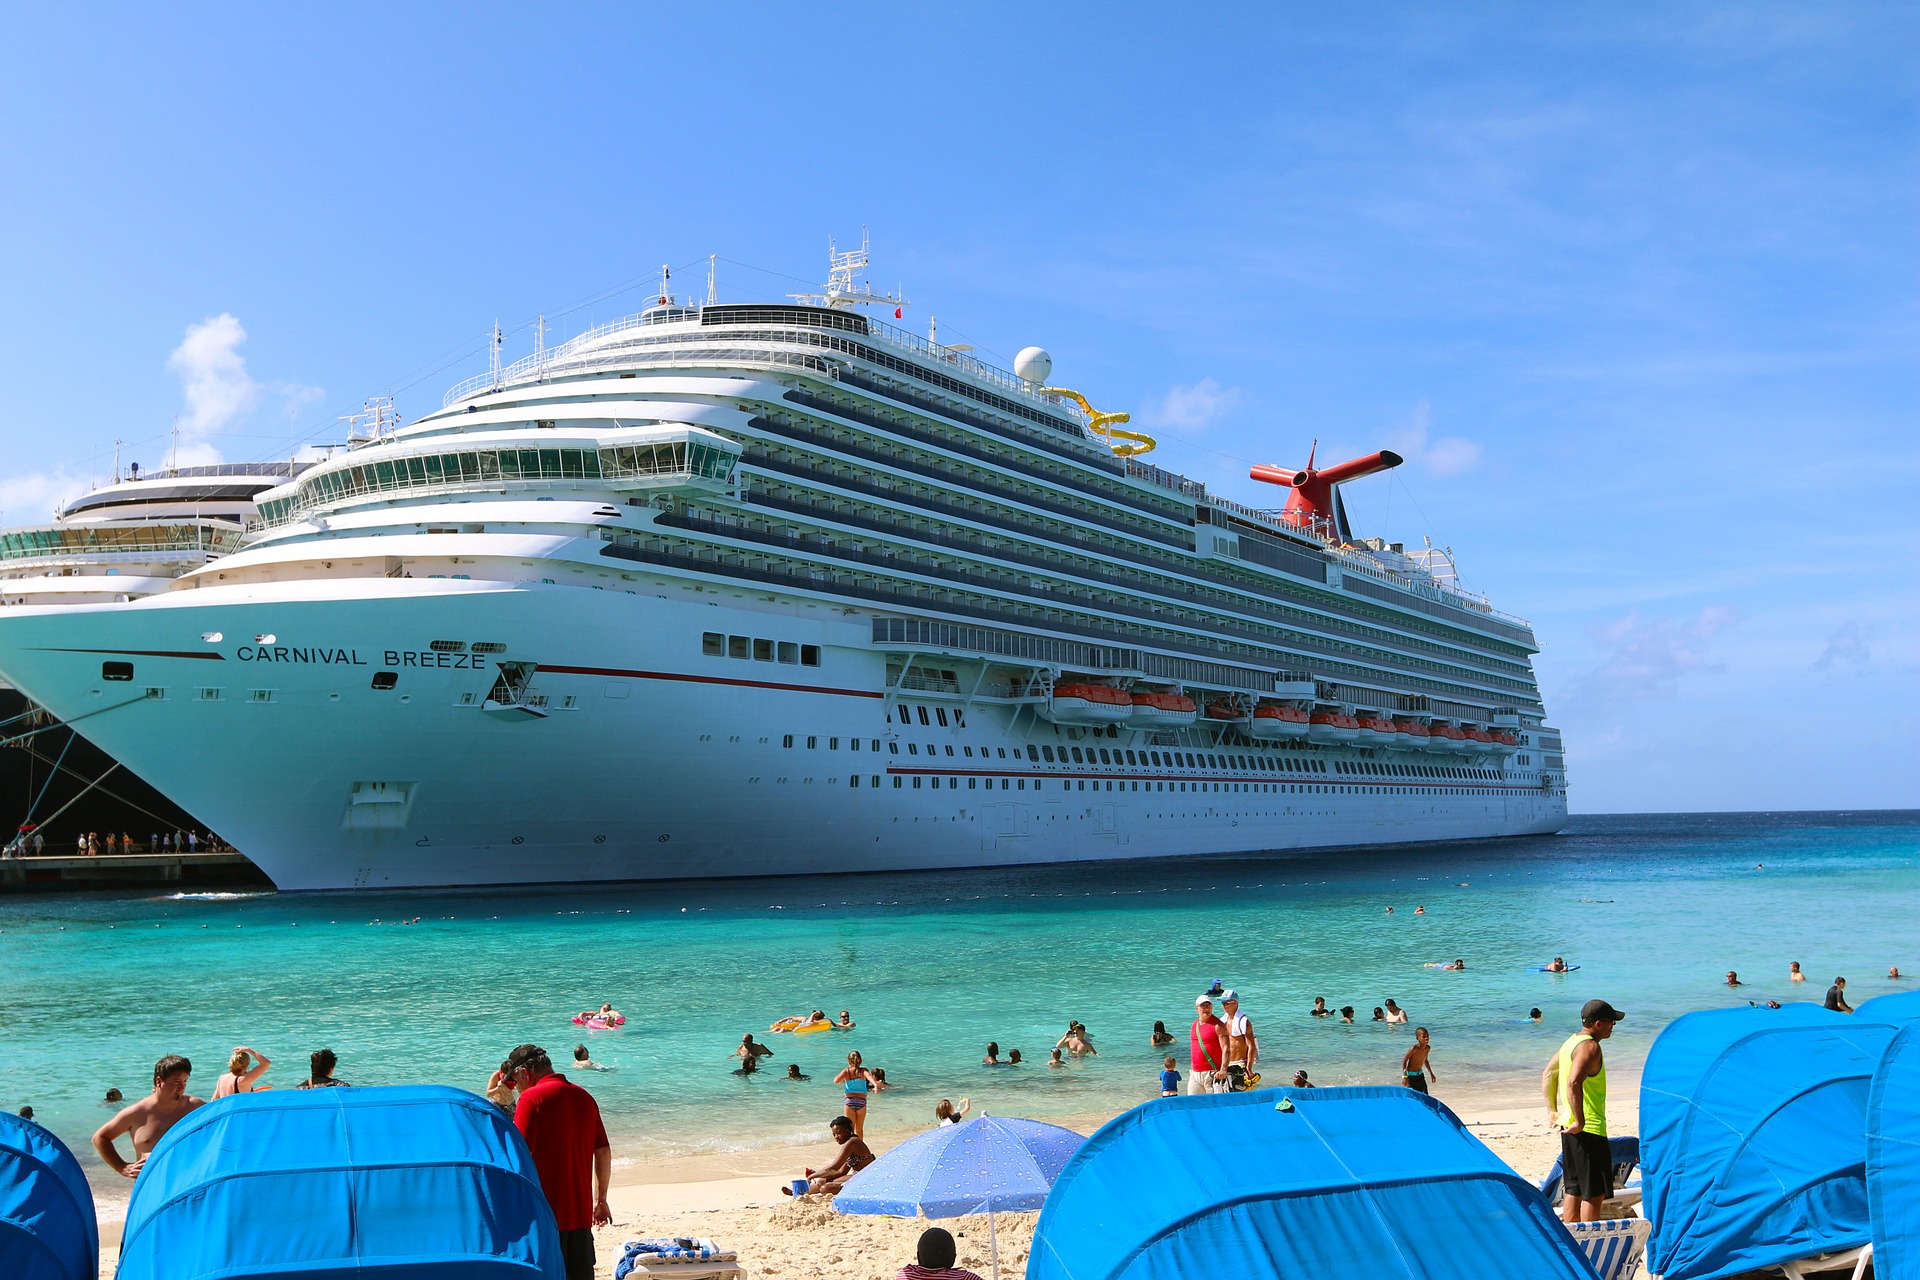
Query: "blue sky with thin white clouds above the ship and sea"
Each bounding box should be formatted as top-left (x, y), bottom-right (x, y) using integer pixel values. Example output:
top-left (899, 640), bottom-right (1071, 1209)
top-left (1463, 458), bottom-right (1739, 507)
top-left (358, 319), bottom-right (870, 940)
top-left (0, 4), bottom-right (1920, 812)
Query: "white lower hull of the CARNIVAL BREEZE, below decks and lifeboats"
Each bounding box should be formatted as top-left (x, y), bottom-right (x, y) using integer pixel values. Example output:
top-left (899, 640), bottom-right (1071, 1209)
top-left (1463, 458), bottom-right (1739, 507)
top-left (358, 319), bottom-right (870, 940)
top-left (0, 580), bottom-right (1567, 890)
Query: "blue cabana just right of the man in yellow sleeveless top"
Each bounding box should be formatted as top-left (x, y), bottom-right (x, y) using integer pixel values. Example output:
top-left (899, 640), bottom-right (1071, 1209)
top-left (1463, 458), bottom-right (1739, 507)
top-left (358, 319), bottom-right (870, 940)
top-left (1640, 1004), bottom-right (1895, 1280)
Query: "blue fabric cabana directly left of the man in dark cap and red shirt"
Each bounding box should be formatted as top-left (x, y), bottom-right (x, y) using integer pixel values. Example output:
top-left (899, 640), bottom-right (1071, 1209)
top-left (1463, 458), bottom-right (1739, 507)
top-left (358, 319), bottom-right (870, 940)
top-left (117, 1084), bottom-right (566, 1280)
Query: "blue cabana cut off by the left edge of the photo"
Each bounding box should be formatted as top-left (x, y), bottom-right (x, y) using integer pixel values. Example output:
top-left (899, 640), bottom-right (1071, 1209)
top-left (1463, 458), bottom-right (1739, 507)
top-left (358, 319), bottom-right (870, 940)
top-left (0, 1115), bottom-right (100, 1280)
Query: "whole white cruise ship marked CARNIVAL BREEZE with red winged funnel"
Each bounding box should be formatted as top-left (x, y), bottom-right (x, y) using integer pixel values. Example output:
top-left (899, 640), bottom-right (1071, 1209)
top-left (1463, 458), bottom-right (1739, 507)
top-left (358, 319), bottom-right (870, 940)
top-left (0, 251), bottom-right (1567, 890)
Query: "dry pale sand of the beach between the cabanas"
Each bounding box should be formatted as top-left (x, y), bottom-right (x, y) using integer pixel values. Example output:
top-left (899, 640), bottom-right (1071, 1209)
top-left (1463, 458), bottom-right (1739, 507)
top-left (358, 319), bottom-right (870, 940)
top-left (100, 1069), bottom-right (1640, 1280)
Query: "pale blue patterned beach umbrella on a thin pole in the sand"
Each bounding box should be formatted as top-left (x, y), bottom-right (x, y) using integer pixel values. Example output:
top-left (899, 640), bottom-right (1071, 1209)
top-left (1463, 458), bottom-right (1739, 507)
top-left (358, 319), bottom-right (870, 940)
top-left (833, 1115), bottom-right (1087, 1276)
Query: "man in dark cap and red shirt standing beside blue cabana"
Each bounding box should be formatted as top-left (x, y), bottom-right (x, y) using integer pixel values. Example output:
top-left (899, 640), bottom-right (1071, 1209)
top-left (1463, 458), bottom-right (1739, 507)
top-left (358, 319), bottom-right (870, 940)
top-left (507, 1044), bottom-right (612, 1280)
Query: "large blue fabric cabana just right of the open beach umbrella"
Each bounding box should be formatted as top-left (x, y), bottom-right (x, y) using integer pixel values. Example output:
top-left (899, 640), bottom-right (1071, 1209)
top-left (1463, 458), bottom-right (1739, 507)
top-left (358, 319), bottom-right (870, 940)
top-left (1027, 1086), bottom-right (1594, 1280)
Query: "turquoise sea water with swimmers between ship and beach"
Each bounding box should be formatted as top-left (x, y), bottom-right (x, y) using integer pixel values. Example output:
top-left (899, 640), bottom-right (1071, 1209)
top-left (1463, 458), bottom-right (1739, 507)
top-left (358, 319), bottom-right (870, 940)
top-left (0, 812), bottom-right (1920, 1173)
